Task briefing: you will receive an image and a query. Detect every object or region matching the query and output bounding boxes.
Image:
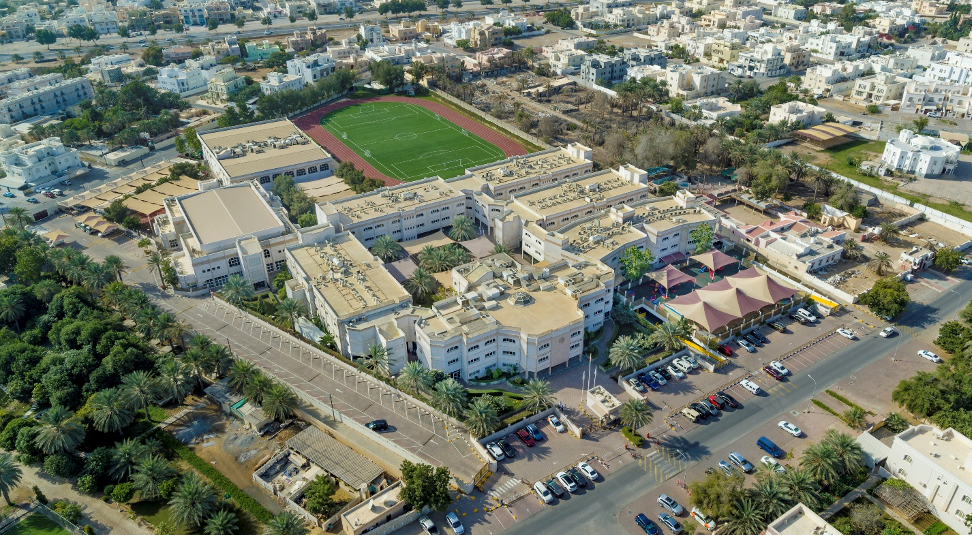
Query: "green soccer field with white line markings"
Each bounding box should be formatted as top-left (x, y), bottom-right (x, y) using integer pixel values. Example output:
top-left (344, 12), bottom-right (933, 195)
top-left (321, 102), bottom-right (506, 182)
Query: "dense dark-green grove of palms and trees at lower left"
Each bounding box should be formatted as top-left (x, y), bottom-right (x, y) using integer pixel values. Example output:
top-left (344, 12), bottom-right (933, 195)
top-left (0, 228), bottom-right (306, 535)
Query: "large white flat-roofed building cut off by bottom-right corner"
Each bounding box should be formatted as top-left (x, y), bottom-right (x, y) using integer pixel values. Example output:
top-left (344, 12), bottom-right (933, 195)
top-left (887, 425), bottom-right (972, 535)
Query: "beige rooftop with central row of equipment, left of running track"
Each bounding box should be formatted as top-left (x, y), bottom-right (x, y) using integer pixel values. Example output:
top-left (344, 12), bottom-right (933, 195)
top-left (200, 119), bottom-right (331, 177)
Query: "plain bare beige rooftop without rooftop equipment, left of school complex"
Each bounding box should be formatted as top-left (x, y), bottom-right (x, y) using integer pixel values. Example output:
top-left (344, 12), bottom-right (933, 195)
top-left (177, 184), bottom-right (284, 245)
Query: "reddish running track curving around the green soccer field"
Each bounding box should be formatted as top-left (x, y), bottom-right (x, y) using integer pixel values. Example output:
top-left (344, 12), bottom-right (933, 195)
top-left (293, 97), bottom-right (527, 186)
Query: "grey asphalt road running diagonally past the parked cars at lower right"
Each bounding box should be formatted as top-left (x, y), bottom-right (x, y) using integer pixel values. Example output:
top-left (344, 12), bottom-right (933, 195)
top-left (503, 268), bottom-right (972, 535)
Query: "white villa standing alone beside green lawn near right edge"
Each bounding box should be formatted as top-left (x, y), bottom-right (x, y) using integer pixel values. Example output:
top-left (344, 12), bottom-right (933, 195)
top-left (881, 130), bottom-right (961, 178)
